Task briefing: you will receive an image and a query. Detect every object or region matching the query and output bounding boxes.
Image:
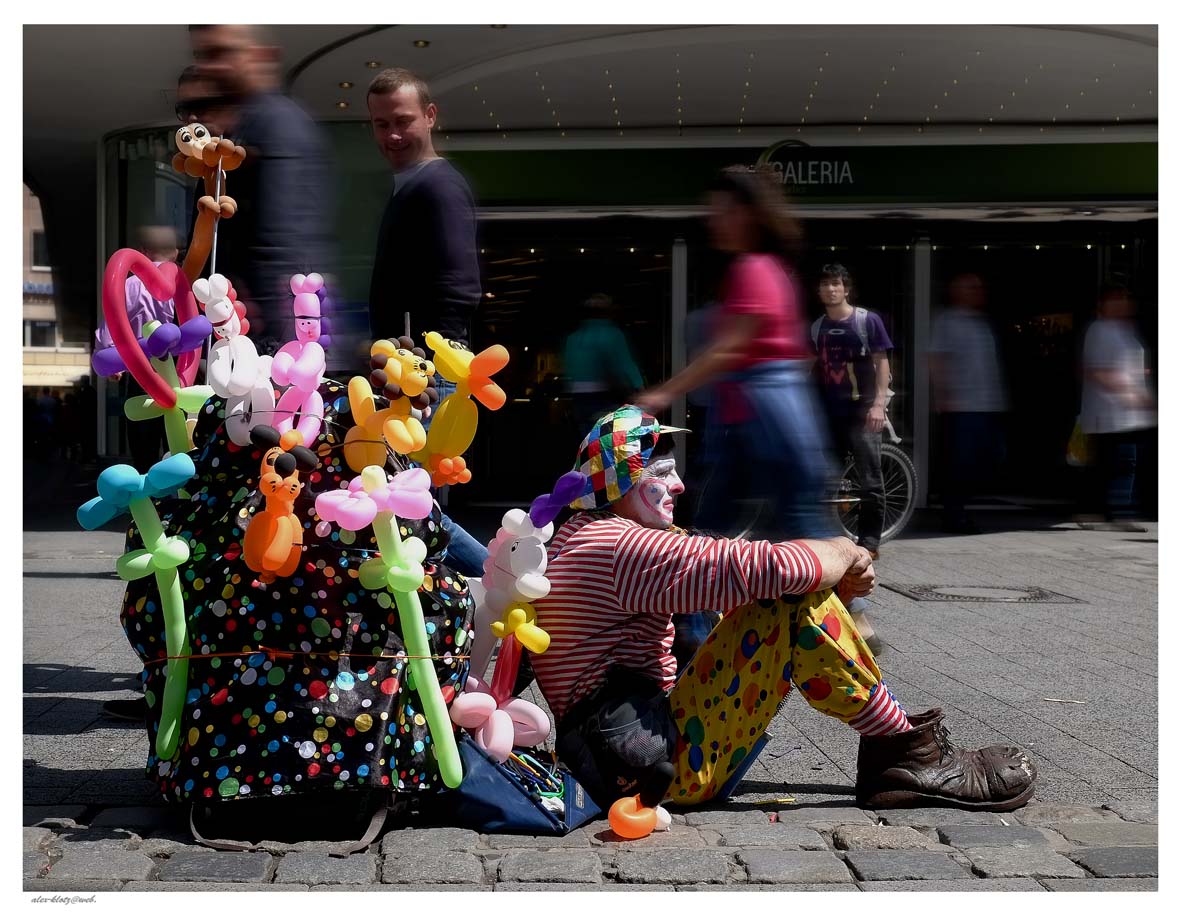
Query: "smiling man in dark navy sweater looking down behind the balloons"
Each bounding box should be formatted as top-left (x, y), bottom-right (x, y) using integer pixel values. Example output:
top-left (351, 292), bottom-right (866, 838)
top-left (365, 68), bottom-right (488, 576)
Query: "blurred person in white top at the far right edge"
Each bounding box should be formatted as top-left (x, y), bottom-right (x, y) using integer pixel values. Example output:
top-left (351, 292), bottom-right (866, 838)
top-left (1079, 286), bottom-right (1156, 531)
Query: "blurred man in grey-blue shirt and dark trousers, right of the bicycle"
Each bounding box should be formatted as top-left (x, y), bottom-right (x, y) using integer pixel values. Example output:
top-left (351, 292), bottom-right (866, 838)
top-left (931, 274), bottom-right (1009, 535)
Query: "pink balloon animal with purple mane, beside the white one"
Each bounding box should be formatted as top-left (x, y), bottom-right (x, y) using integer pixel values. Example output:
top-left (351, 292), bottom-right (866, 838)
top-left (270, 274), bottom-right (326, 445)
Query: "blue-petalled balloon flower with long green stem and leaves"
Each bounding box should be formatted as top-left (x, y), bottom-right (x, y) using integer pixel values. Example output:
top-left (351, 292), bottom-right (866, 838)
top-left (78, 452), bottom-right (197, 760)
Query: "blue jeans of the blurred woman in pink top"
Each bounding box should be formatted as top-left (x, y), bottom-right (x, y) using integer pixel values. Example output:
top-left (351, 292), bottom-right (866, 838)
top-left (697, 360), bottom-right (836, 541)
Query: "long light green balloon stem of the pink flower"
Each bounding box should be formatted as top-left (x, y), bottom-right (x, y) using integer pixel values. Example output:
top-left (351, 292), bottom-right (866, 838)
top-left (373, 512), bottom-right (463, 789)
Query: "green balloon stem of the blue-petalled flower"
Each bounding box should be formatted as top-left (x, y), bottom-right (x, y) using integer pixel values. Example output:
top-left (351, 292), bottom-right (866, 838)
top-left (128, 497), bottom-right (189, 760)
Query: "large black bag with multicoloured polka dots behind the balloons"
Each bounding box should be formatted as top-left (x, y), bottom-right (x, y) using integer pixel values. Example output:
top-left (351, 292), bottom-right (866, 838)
top-left (120, 380), bottom-right (474, 818)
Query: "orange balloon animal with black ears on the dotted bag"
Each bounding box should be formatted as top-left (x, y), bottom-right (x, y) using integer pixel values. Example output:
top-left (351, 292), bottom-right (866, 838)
top-left (242, 426), bottom-right (320, 583)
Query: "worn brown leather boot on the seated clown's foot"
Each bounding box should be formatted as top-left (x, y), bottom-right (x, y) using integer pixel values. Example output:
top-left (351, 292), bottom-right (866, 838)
top-left (857, 709), bottom-right (1037, 811)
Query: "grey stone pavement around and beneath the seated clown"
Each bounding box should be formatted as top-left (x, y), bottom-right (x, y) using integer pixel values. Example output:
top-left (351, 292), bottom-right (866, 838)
top-left (24, 516), bottom-right (1157, 892)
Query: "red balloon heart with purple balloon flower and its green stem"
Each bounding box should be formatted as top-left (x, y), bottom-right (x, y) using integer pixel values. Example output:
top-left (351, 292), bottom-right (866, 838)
top-left (92, 248), bottom-right (214, 454)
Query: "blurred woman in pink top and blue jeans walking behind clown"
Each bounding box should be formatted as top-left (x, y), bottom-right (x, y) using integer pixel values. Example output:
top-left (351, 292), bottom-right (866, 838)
top-left (637, 165), bottom-right (833, 539)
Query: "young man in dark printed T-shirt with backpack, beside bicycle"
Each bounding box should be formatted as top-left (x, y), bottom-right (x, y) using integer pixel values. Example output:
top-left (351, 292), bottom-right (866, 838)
top-left (811, 264), bottom-right (894, 560)
